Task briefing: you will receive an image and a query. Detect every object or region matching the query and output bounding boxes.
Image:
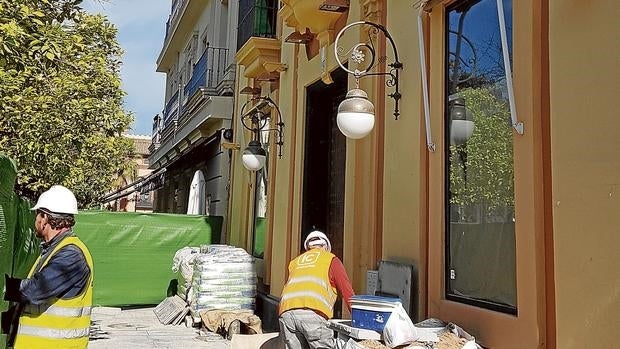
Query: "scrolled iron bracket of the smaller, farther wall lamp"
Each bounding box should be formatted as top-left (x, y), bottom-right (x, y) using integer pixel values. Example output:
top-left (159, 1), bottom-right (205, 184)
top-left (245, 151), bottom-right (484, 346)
top-left (241, 96), bottom-right (284, 158)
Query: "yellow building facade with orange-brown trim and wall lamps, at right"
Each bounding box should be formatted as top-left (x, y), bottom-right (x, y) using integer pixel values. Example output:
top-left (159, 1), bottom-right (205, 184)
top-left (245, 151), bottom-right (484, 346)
top-left (225, 0), bottom-right (620, 348)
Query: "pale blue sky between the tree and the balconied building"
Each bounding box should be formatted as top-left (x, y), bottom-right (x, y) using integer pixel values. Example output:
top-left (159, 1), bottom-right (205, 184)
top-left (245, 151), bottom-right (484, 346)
top-left (82, 0), bottom-right (170, 135)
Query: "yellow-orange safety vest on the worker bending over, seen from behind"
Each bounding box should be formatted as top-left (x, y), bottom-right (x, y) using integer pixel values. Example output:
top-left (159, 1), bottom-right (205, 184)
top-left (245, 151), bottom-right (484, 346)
top-left (279, 248), bottom-right (338, 319)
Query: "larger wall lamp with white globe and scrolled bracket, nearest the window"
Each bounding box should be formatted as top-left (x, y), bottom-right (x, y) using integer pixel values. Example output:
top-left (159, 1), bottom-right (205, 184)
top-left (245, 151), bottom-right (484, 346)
top-left (334, 21), bottom-right (403, 139)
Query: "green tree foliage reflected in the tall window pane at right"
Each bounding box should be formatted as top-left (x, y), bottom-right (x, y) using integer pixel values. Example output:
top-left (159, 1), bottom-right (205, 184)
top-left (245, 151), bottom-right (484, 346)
top-left (450, 88), bottom-right (514, 209)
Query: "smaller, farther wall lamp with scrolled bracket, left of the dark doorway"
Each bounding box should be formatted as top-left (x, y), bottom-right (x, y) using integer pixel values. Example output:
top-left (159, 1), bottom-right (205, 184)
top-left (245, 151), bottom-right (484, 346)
top-left (241, 96), bottom-right (284, 171)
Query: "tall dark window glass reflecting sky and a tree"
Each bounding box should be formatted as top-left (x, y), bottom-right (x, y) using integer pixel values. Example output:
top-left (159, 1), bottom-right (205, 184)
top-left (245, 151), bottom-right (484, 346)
top-left (444, 0), bottom-right (517, 314)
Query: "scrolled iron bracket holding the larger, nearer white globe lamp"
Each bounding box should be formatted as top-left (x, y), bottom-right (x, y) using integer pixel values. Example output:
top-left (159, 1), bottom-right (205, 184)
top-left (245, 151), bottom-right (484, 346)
top-left (334, 21), bottom-right (403, 120)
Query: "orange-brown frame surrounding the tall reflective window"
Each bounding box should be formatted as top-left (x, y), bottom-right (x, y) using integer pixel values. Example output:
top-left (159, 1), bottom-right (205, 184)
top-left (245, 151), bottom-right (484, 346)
top-left (425, 0), bottom-right (552, 348)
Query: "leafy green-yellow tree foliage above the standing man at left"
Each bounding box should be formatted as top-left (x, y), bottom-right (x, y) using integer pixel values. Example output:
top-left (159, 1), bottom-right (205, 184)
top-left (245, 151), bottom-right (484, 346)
top-left (0, 0), bottom-right (133, 207)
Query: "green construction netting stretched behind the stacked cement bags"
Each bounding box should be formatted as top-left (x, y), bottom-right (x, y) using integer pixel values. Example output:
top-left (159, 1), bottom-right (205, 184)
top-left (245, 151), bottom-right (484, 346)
top-left (74, 211), bottom-right (222, 306)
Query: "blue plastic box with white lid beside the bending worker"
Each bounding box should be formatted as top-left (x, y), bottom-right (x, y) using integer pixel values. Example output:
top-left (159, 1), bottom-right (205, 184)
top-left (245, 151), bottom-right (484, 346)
top-left (351, 296), bottom-right (400, 332)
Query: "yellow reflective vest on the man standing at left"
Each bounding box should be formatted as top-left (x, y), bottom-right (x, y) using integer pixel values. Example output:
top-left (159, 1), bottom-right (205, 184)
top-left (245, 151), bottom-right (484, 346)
top-left (14, 236), bottom-right (93, 349)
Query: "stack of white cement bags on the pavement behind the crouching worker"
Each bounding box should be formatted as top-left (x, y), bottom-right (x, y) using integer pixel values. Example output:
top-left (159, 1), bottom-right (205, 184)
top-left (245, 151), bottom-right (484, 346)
top-left (190, 245), bottom-right (256, 313)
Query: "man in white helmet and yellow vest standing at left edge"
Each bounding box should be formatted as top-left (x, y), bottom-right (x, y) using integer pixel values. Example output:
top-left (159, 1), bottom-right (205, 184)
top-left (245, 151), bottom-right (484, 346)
top-left (5, 185), bottom-right (93, 349)
